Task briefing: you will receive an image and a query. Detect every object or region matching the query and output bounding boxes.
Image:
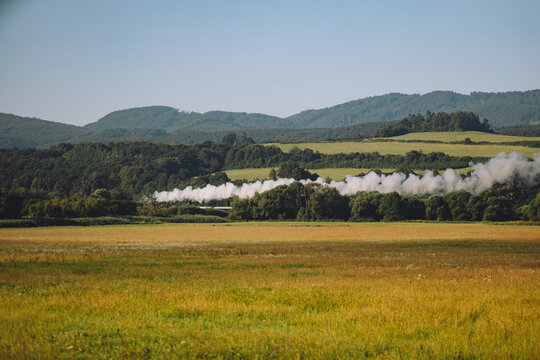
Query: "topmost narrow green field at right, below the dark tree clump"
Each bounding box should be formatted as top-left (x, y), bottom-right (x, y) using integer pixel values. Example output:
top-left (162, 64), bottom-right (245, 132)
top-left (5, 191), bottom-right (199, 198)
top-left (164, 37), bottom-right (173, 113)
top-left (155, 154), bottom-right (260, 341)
top-left (389, 131), bottom-right (540, 143)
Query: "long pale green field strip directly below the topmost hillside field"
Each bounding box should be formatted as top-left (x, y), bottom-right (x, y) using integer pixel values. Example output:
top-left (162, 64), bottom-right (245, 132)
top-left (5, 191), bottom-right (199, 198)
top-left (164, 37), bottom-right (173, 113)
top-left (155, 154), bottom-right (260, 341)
top-left (267, 140), bottom-right (540, 158)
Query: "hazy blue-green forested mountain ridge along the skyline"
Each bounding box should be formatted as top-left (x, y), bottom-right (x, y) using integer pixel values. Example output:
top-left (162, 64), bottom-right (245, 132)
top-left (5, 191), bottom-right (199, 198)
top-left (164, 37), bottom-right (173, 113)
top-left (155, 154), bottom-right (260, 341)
top-left (4, 90), bottom-right (540, 148)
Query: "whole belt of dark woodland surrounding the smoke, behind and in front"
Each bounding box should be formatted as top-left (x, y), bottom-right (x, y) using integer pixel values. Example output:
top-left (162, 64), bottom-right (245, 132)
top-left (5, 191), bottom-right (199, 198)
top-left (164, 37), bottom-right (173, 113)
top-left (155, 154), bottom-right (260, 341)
top-left (0, 138), bottom-right (540, 222)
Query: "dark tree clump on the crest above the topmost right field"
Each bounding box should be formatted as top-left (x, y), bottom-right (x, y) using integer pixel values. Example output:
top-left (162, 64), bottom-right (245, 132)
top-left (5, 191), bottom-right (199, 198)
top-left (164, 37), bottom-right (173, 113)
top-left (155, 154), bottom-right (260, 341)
top-left (375, 111), bottom-right (493, 137)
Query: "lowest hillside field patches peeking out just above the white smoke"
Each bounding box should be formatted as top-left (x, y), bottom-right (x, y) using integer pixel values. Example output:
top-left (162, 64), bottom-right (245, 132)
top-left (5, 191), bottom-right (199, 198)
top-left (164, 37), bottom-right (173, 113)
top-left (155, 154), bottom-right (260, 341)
top-left (225, 167), bottom-right (471, 181)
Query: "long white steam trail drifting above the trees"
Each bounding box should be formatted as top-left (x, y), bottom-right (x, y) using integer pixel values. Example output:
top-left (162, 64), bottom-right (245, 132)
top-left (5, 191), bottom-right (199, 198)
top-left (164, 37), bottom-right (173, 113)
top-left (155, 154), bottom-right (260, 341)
top-left (154, 152), bottom-right (540, 202)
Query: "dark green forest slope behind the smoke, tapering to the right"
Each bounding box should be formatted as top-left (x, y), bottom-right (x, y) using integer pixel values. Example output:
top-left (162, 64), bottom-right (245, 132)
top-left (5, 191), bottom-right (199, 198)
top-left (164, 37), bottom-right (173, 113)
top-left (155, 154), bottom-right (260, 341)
top-left (0, 139), bottom-right (485, 199)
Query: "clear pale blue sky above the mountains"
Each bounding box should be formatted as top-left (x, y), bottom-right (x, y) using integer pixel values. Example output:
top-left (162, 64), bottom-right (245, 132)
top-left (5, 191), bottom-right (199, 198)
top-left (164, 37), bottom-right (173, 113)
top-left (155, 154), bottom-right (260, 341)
top-left (0, 0), bottom-right (540, 125)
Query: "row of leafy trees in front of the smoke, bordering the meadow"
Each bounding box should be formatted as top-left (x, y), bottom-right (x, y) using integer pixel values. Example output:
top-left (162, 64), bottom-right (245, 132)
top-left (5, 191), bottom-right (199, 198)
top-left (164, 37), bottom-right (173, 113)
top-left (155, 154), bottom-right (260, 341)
top-left (230, 179), bottom-right (540, 221)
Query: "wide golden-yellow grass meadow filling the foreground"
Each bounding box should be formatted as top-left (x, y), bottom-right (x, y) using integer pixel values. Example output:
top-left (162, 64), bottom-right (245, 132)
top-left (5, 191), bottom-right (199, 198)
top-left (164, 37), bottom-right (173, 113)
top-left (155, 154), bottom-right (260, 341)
top-left (0, 222), bottom-right (540, 359)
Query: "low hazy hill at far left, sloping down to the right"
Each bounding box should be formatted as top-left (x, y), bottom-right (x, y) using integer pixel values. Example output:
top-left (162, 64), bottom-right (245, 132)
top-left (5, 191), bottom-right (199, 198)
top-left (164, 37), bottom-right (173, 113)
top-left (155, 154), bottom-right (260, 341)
top-left (0, 113), bottom-right (90, 148)
